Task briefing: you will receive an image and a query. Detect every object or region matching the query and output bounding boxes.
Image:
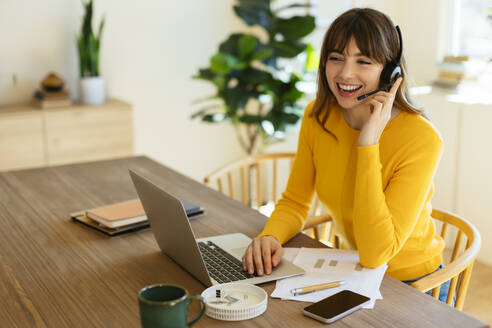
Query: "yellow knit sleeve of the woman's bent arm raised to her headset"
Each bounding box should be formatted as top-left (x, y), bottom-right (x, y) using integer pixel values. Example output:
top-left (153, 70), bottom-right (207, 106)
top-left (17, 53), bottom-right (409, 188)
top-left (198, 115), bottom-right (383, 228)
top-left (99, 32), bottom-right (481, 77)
top-left (353, 133), bottom-right (442, 268)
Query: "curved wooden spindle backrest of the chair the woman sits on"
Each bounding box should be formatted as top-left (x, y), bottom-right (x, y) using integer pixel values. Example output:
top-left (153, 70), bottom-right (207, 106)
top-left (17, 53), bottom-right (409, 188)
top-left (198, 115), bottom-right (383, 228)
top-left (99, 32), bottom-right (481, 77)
top-left (412, 209), bottom-right (482, 310)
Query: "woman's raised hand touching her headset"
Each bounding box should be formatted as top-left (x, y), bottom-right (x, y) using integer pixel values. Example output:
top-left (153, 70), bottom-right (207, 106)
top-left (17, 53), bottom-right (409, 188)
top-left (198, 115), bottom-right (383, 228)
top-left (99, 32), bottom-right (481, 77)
top-left (359, 77), bottom-right (402, 146)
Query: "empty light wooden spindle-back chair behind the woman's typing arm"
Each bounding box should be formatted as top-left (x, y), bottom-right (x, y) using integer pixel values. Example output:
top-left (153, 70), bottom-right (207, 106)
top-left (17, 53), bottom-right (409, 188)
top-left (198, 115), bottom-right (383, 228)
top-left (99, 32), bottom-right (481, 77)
top-left (204, 153), bottom-right (336, 246)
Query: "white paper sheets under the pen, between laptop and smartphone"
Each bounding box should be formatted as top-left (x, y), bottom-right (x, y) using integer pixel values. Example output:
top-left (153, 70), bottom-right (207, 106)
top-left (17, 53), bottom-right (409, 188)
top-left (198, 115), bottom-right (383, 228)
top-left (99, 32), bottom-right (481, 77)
top-left (270, 248), bottom-right (387, 309)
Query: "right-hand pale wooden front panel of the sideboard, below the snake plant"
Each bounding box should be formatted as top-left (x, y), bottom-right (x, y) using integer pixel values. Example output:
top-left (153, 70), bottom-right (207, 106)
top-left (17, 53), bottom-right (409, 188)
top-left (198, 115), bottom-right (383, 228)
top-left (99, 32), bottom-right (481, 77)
top-left (45, 107), bottom-right (133, 165)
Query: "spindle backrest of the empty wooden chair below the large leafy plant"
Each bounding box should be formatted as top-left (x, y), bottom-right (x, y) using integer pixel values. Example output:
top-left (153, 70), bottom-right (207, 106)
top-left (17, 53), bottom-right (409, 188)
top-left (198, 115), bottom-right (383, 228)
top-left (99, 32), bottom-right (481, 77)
top-left (204, 153), bottom-right (321, 215)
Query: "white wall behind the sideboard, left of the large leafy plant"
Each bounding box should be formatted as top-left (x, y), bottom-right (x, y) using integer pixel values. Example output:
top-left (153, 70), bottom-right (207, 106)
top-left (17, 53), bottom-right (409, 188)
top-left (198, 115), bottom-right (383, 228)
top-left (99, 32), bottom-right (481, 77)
top-left (0, 0), bottom-right (244, 180)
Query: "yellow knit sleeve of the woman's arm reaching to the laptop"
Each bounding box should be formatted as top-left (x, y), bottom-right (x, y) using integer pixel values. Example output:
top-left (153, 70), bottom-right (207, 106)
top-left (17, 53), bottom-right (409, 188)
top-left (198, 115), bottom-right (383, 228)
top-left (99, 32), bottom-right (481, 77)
top-left (259, 103), bottom-right (315, 244)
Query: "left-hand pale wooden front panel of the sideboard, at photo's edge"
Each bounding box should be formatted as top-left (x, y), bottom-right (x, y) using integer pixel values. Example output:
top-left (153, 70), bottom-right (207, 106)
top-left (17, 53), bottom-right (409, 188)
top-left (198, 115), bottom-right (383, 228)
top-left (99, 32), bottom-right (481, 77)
top-left (0, 113), bottom-right (46, 171)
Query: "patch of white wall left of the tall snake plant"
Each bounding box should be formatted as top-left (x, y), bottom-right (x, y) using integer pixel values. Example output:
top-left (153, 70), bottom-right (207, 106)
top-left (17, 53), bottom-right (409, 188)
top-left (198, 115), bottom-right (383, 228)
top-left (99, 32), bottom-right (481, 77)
top-left (0, 0), bottom-right (80, 104)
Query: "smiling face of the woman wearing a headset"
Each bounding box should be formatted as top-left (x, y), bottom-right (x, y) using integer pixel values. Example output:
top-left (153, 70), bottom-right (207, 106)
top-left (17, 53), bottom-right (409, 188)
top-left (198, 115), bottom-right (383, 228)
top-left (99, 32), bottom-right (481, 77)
top-left (325, 38), bottom-right (383, 109)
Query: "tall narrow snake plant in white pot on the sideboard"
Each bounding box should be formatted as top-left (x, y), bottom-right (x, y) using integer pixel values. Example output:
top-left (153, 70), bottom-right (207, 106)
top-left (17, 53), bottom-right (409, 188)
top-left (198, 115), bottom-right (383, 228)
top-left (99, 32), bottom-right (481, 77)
top-left (77, 0), bottom-right (105, 105)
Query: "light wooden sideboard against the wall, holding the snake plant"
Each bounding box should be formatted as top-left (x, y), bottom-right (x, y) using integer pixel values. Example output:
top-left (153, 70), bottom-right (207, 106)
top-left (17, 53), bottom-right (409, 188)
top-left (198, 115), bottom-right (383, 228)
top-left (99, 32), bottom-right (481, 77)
top-left (0, 99), bottom-right (133, 171)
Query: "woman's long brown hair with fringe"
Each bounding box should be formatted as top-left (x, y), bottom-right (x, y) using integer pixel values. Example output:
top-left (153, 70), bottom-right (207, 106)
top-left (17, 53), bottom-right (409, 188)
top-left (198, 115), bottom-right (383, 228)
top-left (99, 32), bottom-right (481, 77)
top-left (309, 8), bottom-right (427, 138)
